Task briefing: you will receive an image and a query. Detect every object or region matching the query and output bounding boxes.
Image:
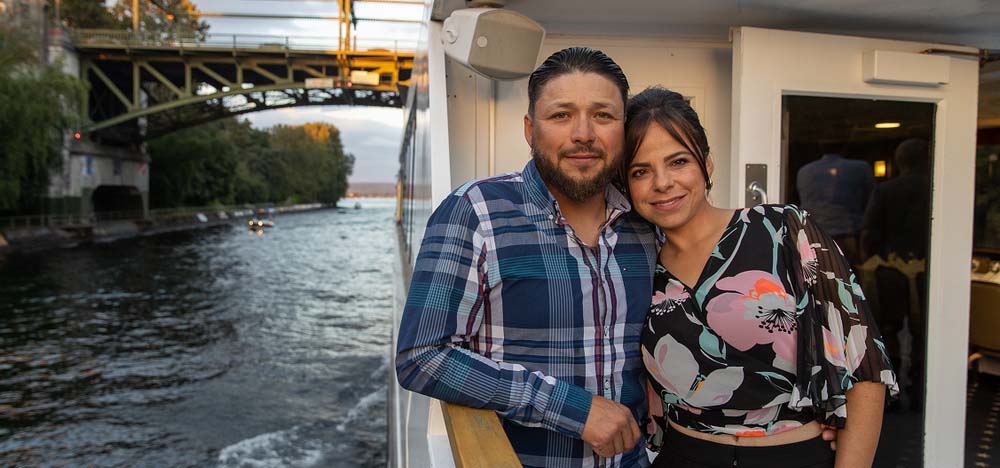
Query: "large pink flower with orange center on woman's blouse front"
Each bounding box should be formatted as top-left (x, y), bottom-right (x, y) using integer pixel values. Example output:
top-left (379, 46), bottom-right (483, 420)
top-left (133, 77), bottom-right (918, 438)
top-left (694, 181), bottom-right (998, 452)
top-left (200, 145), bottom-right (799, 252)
top-left (705, 270), bottom-right (797, 372)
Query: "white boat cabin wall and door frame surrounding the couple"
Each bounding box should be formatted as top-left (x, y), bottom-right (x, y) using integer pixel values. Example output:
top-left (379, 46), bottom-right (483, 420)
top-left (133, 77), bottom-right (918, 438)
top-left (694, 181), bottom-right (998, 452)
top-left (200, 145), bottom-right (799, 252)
top-left (388, 0), bottom-right (1000, 467)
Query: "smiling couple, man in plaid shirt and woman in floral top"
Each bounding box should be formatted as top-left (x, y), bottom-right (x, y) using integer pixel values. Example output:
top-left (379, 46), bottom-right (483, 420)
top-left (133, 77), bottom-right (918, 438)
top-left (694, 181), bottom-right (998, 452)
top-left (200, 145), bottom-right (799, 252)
top-left (396, 47), bottom-right (897, 468)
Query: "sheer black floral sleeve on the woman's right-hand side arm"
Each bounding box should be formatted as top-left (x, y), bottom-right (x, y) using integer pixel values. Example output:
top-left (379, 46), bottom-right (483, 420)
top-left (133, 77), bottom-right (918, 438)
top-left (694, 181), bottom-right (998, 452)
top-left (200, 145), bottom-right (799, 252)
top-left (784, 205), bottom-right (899, 427)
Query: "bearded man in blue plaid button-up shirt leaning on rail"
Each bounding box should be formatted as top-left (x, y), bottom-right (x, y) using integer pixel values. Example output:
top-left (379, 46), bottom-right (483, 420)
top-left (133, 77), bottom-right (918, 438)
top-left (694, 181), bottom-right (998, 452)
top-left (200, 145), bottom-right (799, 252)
top-left (396, 48), bottom-right (657, 467)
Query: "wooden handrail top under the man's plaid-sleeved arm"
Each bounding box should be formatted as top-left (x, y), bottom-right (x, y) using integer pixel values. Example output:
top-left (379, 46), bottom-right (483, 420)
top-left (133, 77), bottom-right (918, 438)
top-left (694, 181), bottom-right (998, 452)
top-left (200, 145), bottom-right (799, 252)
top-left (441, 402), bottom-right (521, 468)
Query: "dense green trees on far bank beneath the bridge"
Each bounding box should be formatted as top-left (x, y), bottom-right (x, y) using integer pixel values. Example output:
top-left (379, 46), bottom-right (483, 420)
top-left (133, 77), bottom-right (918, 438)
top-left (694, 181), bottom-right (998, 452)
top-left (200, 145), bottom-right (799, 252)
top-left (149, 119), bottom-right (354, 208)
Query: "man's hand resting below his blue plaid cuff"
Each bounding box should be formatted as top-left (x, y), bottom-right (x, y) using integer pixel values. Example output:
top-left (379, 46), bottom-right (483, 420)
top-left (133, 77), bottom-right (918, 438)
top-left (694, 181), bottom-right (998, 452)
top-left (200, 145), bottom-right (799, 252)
top-left (581, 395), bottom-right (641, 458)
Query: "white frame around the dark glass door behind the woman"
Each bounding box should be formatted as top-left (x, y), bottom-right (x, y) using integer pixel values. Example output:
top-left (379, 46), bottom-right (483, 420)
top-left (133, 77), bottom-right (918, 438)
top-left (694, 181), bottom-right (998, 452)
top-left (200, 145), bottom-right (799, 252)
top-left (730, 27), bottom-right (979, 466)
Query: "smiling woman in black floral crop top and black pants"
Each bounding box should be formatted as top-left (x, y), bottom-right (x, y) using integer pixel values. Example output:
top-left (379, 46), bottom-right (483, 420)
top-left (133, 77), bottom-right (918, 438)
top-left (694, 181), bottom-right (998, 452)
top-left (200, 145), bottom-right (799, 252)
top-left (621, 88), bottom-right (898, 468)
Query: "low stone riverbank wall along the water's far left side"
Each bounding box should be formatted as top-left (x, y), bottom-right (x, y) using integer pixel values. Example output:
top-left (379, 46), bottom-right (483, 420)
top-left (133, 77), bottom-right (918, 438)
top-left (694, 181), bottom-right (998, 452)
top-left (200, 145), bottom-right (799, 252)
top-left (0, 203), bottom-right (335, 253)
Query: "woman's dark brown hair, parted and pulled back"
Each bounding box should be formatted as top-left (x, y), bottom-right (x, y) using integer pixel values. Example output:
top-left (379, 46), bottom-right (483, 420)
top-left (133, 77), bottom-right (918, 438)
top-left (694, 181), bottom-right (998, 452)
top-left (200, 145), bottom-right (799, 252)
top-left (618, 86), bottom-right (712, 193)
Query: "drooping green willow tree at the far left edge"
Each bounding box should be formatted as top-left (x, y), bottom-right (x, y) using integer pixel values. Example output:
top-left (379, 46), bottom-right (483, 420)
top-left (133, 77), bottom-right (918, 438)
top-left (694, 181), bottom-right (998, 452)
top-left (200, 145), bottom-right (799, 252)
top-left (0, 27), bottom-right (87, 212)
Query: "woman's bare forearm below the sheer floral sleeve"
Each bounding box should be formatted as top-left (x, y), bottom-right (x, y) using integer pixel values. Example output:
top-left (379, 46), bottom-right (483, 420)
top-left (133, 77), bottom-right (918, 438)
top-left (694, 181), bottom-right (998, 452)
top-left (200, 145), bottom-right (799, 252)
top-left (836, 382), bottom-right (885, 468)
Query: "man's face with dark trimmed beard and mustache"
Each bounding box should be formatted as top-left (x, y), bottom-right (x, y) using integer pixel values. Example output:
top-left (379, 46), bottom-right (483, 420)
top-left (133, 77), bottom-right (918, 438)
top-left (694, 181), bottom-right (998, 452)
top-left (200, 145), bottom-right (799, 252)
top-left (524, 73), bottom-right (625, 202)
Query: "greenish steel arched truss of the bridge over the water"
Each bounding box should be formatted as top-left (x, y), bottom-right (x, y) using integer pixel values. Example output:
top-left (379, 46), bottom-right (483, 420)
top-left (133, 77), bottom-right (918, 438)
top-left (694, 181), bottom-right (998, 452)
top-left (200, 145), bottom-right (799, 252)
top-left (72, 26), bottom-right (414, 143)
